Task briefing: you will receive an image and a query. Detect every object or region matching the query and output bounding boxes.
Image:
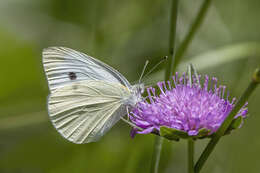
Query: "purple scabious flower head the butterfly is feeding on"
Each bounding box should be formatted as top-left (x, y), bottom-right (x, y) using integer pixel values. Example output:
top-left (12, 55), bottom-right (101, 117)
top-left (128, 73), bottom-right (248, 140)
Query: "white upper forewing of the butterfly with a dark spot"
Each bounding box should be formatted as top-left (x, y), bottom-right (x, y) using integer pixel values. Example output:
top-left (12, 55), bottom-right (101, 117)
top-left (43, 47), bottom-right (131, 92)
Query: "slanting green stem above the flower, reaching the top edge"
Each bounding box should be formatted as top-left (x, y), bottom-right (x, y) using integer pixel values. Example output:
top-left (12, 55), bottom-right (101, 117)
top-left (174, 0), bottom-right (212, 68)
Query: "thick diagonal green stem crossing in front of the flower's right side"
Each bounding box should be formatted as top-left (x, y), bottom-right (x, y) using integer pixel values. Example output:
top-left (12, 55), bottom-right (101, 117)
top-left (195, 69), bottom-right (260, 173)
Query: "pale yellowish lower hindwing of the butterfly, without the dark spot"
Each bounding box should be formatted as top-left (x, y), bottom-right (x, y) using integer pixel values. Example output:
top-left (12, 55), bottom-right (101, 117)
top-left (48, 80), bottom-right (130, 144)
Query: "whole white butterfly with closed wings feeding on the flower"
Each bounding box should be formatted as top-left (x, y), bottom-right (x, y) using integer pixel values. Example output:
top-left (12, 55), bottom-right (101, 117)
top-left (43, 47), bottom-right (144, 144)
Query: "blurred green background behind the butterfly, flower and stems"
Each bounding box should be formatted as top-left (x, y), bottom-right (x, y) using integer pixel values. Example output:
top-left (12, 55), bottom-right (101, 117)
top-left (0, 0), bottom-right (260, 173)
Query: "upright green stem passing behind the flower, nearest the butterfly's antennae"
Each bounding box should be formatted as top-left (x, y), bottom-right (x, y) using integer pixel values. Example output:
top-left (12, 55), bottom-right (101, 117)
top-left (150, 0), bottom-right (179, 173)
